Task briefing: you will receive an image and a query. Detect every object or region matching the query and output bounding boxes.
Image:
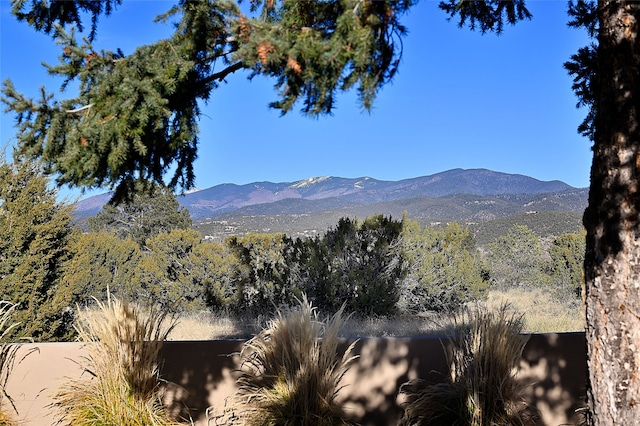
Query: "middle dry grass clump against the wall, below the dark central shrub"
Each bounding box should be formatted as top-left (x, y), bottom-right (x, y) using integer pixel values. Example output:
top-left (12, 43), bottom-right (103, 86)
top-left (226, 298), bottom-right (355, 426)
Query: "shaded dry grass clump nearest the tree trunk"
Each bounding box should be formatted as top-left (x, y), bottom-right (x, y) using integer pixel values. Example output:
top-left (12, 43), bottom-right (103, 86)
top-left (400, 306), bottom-right (539, 426)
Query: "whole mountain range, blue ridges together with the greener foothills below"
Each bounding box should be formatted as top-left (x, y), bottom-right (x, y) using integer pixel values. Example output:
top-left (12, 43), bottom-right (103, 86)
top-left (75, 169), bottom-right (588, 241)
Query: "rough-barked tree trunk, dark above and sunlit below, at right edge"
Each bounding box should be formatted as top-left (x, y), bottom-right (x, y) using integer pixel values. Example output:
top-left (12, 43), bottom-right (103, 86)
top-left (584, 1), bottom-right (640, 425)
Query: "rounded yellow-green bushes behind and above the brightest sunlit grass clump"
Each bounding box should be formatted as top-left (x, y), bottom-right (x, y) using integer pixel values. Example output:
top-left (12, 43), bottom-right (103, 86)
top-left (63, 230), bottom-right (214, 312)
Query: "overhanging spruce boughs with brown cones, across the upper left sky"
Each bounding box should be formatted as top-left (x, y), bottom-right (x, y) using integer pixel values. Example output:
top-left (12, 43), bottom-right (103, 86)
top-left (1, 0), bottom-right (413, 199)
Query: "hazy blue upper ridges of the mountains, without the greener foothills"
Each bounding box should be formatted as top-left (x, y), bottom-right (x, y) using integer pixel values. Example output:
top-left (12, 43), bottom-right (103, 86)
top-left (75, 169), bottom-right (575, 220)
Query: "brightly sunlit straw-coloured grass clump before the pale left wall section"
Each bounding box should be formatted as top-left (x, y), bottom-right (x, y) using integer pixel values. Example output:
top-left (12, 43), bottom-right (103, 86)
top-left (54, 298), bottom-right (184, 426)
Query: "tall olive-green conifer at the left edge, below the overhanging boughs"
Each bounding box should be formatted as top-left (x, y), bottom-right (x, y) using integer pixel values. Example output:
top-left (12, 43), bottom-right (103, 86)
top-left (0, 155), bottom-right (73, 341)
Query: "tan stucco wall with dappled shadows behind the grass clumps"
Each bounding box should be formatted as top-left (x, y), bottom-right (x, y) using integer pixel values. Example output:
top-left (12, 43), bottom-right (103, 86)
top-left (7, 333), bottom-right (586, 426)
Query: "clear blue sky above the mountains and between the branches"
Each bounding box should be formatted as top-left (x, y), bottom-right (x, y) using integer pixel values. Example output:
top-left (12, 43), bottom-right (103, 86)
top-left (0, 0), bottom-right (592, 201)
